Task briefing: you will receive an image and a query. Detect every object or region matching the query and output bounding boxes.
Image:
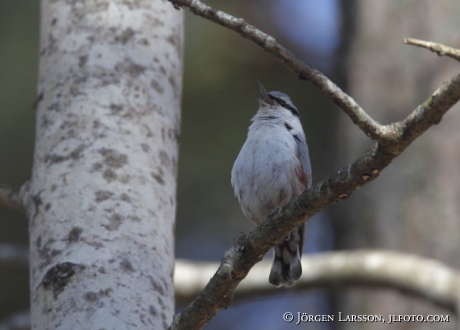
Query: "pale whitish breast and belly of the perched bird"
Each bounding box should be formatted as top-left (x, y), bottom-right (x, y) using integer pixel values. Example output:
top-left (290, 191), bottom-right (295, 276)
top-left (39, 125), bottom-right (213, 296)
top-left (232, 120), bottom-right (305, 224)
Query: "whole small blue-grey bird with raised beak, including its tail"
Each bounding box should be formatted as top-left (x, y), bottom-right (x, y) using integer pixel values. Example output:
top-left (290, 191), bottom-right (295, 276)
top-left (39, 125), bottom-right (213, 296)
top-left (231, 82), bottom-right (312, 287)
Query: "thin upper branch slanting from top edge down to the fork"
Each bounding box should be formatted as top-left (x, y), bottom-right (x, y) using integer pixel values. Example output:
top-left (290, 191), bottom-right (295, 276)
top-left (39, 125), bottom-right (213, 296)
top-left (168, 0), bottom-right (386, 142)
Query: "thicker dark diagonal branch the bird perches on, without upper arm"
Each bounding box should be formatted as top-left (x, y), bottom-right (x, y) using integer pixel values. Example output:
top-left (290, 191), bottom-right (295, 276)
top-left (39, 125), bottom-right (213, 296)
top-left (171, 74), bottom-right (460, 329)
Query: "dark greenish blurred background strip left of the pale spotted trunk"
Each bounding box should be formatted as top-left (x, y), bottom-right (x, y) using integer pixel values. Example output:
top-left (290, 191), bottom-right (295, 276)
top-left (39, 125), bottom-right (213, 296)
top-left (0, 0), bottom-right (39, 320)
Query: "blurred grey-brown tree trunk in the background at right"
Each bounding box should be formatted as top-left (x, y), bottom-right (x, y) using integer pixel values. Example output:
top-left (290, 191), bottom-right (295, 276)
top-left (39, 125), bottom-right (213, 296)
top-left (336, 0), bottom-right (460, 329)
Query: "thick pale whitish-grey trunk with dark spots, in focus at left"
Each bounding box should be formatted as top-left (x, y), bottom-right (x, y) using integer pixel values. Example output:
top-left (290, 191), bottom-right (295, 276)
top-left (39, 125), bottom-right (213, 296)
top-left (27, 0), bottom-right (183, 330)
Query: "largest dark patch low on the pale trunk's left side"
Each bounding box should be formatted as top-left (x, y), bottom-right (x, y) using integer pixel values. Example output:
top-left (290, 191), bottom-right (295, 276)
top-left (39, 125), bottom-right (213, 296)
top-left (42, 262), bottom-right (85, 299)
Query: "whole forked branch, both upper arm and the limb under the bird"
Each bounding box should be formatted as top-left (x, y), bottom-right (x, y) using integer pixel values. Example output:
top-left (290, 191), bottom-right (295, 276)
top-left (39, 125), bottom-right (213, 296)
top-left (169, 0), bottom-right (460, 329)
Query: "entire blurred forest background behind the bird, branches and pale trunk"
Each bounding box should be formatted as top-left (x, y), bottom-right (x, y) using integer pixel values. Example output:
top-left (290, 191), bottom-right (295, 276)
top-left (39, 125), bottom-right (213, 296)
top-left (0, 0), bottom-right (460, 330)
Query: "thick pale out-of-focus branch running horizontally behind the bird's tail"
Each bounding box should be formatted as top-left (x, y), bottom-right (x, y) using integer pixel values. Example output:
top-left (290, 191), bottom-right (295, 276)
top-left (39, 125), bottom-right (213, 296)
top-left (174, 250), bottom-right (460, 313)
